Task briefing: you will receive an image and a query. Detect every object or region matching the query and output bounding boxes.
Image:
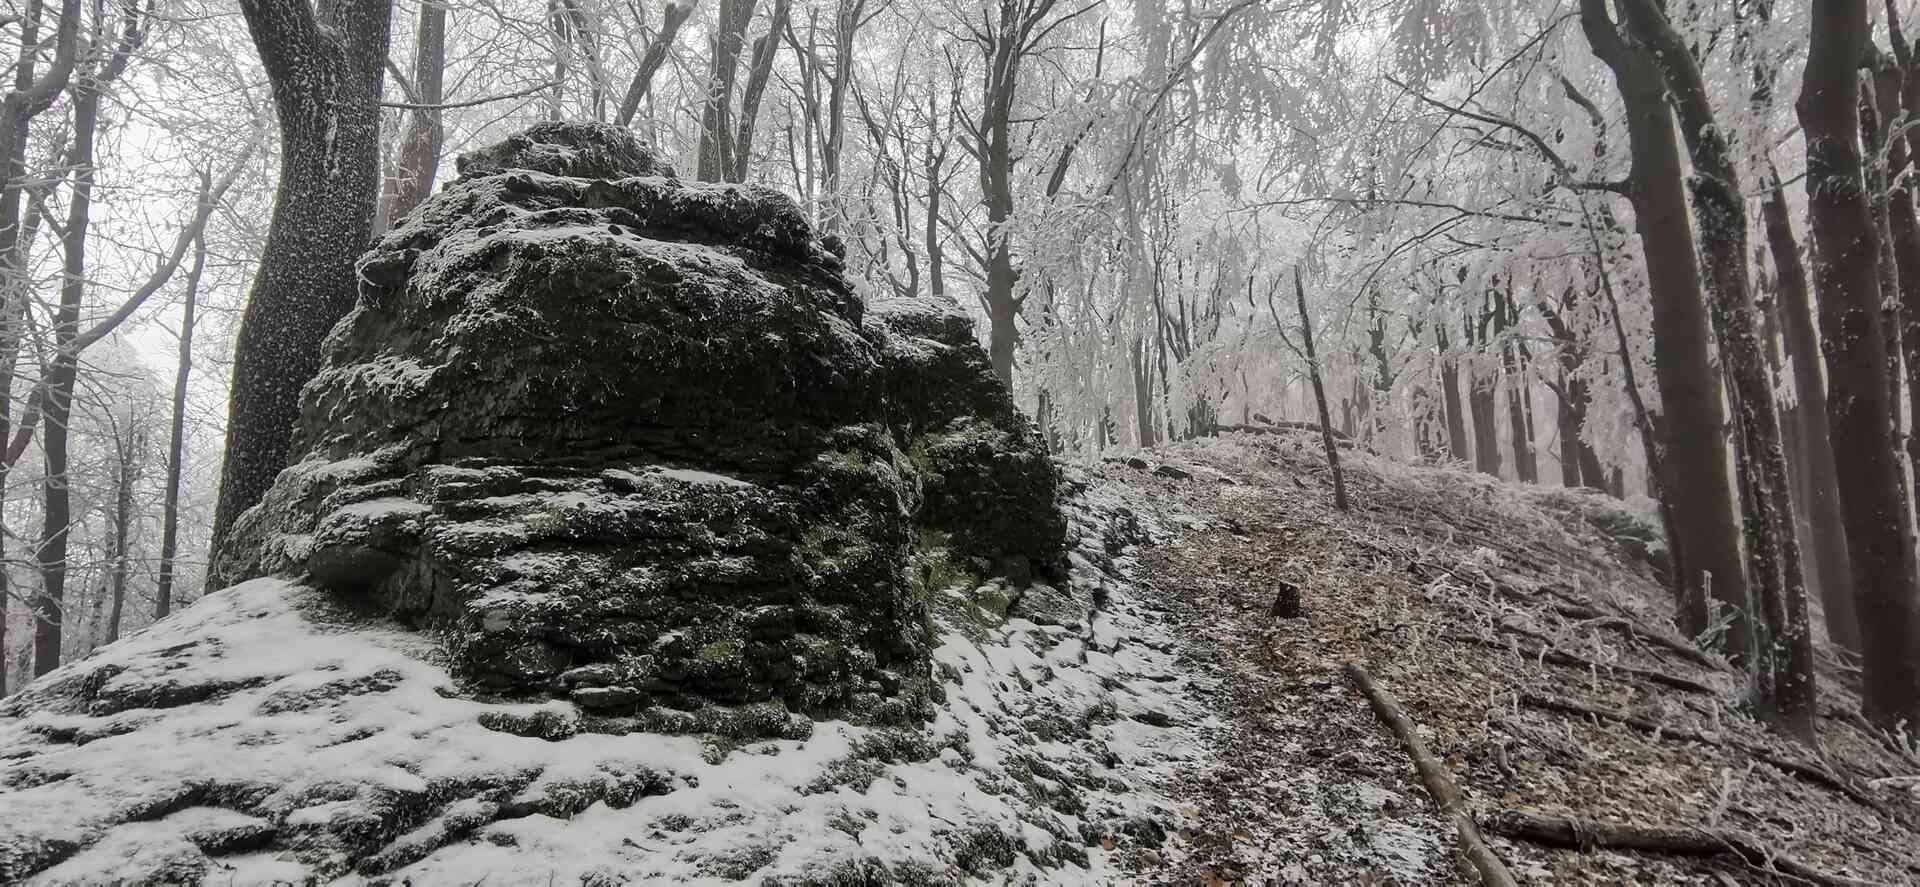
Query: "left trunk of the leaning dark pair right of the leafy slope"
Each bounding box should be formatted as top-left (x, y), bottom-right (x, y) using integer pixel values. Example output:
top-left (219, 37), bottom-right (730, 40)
top-left (1580, 0), bottom-right (1749, 651)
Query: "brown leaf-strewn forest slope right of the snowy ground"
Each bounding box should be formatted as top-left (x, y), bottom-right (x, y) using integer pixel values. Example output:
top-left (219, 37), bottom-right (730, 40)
top-left (1098, 434), bottom-right (1920, 885)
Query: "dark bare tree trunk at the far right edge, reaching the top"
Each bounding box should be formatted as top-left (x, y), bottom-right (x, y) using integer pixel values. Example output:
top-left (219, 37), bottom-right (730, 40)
top-left (1795, 0), bottom-right (1920, 724)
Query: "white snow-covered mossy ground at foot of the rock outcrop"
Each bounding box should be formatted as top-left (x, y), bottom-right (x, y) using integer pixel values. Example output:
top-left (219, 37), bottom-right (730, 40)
top-left (0, 470), bottom-right (1206, 885)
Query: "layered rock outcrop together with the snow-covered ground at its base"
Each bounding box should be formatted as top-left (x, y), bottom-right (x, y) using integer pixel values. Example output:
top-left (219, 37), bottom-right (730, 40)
top-left (0, 123), bottom-right (1200, 883)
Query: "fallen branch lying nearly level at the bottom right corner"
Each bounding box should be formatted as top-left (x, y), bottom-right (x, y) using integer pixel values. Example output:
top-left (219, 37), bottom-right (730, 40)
top-left (1486, 810), bottom-right (1878, 887)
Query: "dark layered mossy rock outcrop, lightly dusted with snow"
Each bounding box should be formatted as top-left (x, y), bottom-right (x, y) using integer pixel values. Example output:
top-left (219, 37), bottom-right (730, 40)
top-left (211, 123), bottom-right (1066, 733)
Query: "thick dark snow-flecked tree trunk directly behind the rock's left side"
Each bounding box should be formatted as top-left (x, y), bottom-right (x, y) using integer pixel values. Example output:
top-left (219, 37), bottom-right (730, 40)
top-left (213, 0), bottom-right (392, 543)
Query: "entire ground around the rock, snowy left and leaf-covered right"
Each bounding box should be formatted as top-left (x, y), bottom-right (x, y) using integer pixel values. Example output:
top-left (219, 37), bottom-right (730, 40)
top-left (0, 434), bottom-right (1920, 885)
